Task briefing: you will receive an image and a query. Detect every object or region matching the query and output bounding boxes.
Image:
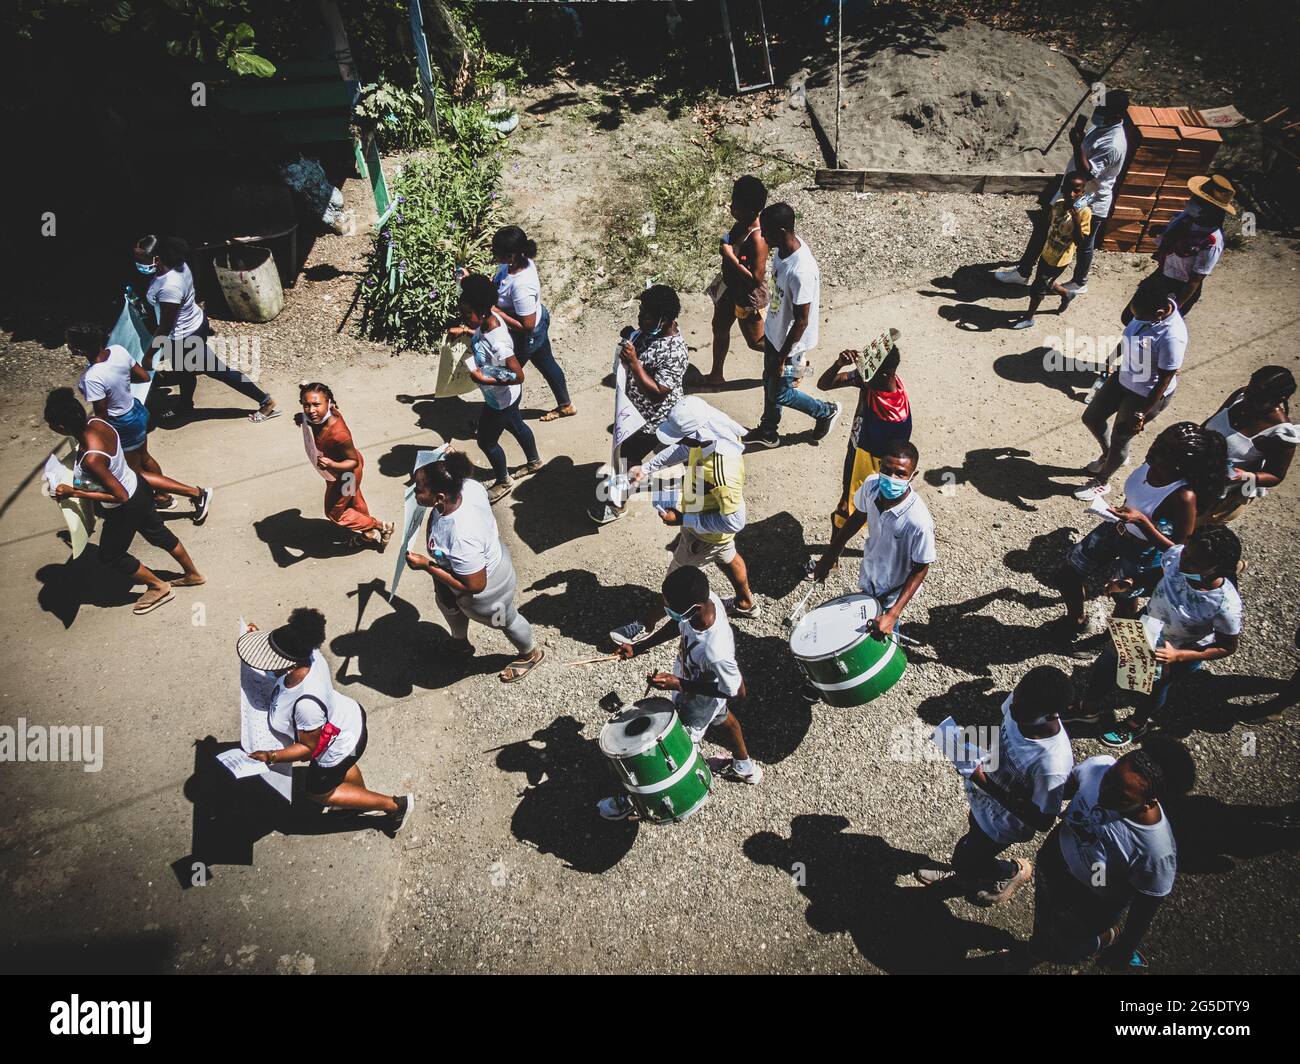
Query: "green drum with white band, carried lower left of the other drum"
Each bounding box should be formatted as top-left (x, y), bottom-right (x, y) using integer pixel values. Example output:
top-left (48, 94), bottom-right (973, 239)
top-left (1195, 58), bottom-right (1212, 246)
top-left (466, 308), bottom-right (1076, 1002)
top-left (601, 698), bottom-right (714, 823)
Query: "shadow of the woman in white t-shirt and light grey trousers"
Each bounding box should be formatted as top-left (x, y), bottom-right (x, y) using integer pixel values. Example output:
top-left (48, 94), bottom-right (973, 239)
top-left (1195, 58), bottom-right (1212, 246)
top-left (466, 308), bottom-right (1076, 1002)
top-left (329, 572), bottom-right (515, 698)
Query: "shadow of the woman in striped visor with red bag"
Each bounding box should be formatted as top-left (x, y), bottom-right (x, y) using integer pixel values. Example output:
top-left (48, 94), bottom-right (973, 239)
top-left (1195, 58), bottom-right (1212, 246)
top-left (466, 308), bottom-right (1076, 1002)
top-left (172, 735), bottom-right (387, 890)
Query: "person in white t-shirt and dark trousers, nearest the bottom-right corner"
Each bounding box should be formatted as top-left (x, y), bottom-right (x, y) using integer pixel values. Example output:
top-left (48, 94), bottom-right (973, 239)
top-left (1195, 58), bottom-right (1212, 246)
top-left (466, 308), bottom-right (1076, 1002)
top-left (1030, 736), bottom-right (1196, 968)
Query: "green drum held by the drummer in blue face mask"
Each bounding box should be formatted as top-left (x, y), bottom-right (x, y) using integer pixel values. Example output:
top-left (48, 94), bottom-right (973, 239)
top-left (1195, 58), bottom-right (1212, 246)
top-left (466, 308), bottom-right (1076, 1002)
top-left (790, 594), bottom-right (907, 706)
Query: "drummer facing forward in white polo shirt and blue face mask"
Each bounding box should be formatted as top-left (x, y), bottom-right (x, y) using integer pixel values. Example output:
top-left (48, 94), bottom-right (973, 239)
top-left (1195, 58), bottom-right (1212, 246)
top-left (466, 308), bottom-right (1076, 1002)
top-left (813, 440), bottom-right (936, 636)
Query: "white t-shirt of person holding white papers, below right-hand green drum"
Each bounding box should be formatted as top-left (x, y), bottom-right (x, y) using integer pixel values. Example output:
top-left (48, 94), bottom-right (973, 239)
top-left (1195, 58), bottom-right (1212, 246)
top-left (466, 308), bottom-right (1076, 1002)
top-left (966, 695), bottom-right (1074, 845)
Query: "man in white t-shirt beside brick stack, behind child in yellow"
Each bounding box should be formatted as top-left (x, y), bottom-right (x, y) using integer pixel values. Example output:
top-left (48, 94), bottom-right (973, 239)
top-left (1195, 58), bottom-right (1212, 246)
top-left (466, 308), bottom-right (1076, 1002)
top-left (993, 90), bottom-right (1128, 297)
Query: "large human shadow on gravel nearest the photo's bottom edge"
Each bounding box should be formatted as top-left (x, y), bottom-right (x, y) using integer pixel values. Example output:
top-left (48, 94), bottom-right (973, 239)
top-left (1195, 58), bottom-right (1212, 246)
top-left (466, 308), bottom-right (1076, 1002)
top-left (744, 814), bottom-right (1015, 974)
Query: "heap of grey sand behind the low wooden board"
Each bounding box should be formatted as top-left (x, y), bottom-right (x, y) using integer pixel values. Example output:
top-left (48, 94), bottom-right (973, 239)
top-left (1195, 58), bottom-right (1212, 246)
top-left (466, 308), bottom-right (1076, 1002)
top-left (806, 4), bottom-right (1087, 173)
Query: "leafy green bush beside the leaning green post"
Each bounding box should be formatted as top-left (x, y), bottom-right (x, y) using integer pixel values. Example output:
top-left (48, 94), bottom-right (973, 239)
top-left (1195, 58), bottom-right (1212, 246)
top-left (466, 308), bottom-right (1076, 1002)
top-left (360, 105), bottom-right (502, 349)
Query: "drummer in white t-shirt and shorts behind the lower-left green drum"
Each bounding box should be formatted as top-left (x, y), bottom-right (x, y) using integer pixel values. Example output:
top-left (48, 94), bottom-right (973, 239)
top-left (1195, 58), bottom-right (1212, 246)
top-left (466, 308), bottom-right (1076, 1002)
top-left (597, 565), bottom-right (763, 821)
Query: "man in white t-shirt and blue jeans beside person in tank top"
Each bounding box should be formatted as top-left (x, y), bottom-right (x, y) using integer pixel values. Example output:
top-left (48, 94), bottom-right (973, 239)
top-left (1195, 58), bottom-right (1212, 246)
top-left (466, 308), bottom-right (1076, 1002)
top-left (745, 203), bottom-right (840, 447)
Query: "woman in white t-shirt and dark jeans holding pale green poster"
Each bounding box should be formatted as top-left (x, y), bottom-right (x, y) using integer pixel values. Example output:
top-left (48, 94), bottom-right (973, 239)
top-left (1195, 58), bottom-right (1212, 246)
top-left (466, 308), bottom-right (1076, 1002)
top-left (449, 273), bottom-right (542, 502)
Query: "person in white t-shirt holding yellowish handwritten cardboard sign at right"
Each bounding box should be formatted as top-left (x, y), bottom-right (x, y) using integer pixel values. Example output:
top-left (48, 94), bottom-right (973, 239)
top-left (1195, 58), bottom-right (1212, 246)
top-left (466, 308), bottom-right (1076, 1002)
top-left (1066, 525), bottom-right (1242, 747)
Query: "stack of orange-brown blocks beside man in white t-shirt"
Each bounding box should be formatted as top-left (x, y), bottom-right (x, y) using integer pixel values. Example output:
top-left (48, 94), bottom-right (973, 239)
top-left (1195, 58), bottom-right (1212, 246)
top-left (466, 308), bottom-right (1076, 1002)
top-left (1101, 107), bottom-right (1223, 251)
